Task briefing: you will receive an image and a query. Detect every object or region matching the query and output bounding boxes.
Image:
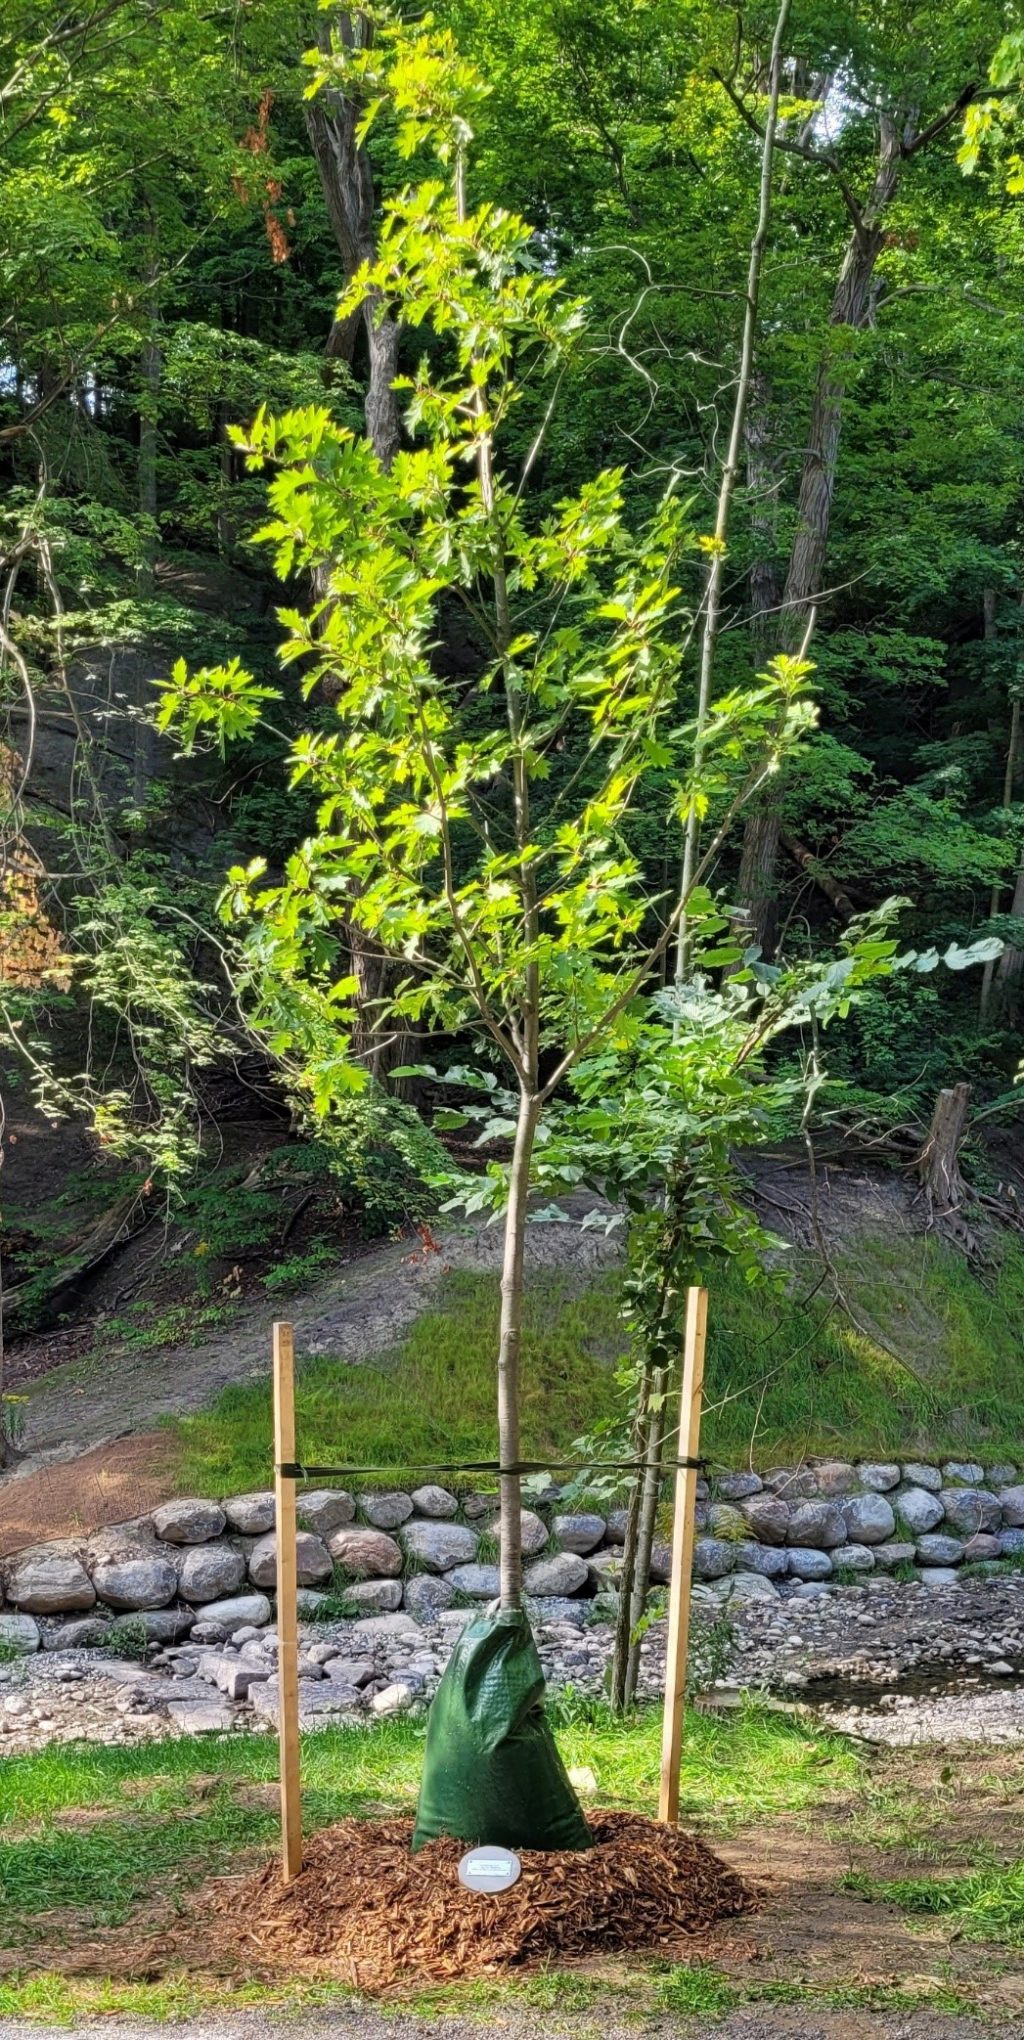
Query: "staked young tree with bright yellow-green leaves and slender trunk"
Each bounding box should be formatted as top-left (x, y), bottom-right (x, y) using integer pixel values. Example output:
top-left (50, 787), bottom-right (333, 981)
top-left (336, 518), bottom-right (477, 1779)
top-left (161, 11), bottom-right (812, 1608)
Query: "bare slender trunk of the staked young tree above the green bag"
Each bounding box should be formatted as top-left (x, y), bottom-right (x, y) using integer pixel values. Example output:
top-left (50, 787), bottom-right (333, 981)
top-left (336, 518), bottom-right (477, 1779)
top-left (498, 1089), bottom-right (541, 1608)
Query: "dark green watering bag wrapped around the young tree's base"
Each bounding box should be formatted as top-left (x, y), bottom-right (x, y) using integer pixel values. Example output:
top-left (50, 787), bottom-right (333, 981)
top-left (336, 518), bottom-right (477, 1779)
top-left (412, 1608), bottom-right (592, 1854)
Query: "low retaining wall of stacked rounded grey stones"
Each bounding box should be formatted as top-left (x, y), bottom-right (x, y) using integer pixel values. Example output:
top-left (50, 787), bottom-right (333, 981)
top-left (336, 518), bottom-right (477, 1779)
top-left (0, 1461), bottom-right (1024, 1650)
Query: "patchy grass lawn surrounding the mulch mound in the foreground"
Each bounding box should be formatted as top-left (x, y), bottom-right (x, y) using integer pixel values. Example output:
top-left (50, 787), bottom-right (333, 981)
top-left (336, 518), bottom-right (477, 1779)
top-left (0, 1693), bottom-right (1024, 2036)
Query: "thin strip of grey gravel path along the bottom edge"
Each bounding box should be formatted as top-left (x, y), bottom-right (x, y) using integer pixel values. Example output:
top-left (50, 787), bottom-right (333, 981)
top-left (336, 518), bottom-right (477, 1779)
top-left (0, 2005), bottom-right (1007, 2040)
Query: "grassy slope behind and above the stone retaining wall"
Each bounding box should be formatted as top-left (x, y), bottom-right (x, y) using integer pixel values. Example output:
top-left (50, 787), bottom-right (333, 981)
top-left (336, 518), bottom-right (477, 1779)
top-left (171, 1240), bottom-right (1024, 1495)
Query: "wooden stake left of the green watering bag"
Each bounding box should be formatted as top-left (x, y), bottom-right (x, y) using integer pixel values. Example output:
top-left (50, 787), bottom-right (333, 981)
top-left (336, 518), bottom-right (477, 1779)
top-left (273, 1324), bottom-right (302, 1885)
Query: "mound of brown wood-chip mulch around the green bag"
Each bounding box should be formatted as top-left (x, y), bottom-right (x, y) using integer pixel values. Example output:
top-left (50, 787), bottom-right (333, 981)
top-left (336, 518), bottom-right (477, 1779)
top-left (206, 1812), bottom-right (761, 1993)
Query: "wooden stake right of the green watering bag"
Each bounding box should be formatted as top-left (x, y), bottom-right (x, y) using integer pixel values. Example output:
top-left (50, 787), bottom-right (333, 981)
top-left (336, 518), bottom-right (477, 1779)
top-left (659, 1289), bottom-right (708, 1828)
